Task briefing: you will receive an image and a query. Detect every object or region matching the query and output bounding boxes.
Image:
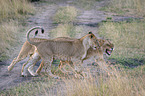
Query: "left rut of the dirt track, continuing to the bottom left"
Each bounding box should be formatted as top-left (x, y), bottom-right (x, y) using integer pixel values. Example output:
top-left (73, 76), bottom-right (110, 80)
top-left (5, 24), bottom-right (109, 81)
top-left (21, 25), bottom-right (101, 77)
top-left (0, 4), bottom-right (58, 91)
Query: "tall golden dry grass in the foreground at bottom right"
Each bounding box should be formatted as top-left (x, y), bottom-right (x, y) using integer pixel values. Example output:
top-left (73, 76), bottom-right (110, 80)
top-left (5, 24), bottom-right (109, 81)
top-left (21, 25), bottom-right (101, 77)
top-left (65, 67), bottom-right (145, 96)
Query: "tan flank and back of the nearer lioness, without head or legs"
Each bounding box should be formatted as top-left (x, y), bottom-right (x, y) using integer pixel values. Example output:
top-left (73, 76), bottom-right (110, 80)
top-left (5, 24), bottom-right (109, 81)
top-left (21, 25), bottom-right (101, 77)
top-left (37, 40), bottom-right (84, 57)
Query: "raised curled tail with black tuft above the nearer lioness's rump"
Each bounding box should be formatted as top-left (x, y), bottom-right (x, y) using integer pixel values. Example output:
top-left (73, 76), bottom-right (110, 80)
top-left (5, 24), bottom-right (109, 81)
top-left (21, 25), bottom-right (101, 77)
top-left (26, 26), bottom-right (44, 45)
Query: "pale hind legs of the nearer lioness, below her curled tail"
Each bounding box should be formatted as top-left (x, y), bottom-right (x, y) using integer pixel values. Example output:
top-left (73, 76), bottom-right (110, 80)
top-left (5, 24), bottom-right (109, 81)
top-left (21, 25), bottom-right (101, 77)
top-left (22, 52), bottom-right (40, 76)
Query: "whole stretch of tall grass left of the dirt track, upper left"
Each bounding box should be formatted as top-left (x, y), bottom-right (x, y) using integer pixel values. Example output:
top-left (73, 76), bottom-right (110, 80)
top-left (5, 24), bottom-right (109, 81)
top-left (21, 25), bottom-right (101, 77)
top-left (0, 0), bottom-right (34, 60)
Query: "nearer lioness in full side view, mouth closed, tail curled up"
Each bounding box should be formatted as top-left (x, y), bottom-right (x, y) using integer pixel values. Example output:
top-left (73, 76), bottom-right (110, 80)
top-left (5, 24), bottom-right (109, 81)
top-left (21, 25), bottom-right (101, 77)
top-left (22, 27), bottom-right (99, 77)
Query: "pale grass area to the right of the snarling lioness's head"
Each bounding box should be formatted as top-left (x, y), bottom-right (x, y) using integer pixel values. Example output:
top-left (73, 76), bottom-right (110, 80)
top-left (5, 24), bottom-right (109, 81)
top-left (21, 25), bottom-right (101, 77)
top-left (99, 20), bottom-right (145, 66)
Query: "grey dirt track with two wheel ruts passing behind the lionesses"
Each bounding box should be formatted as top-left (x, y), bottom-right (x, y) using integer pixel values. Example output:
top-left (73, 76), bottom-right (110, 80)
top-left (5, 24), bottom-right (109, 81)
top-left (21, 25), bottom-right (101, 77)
top-left (0, 0), bottom-right (124, 91)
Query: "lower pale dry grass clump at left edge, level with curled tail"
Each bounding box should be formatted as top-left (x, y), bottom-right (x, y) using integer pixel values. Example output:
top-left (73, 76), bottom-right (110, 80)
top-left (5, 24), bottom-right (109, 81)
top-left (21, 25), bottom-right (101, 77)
top-left (0, 20), bottom-right (20, 59)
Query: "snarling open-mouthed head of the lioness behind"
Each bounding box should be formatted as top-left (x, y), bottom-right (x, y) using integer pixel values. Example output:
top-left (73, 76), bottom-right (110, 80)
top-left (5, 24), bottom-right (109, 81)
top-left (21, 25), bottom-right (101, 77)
top-left (98, 39), bottom-right (114, 56)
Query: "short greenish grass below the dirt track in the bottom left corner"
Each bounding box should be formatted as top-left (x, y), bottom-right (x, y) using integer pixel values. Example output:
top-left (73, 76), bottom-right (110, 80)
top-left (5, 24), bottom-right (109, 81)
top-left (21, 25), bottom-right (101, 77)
top-left (0, 77), bottom-right (56, 96)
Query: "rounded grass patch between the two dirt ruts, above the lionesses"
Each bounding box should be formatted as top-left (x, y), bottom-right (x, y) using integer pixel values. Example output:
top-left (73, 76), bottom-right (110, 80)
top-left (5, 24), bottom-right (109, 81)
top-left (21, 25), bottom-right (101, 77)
top-left (53, 6), bottom-right (77, 24)
